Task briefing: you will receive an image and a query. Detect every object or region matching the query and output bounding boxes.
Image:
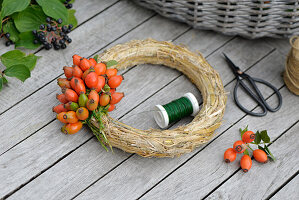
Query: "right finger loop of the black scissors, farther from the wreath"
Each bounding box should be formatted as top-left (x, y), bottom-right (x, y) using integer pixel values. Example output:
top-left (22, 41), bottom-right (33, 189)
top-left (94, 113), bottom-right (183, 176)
top-left (250, 77), bottom-right (282, 112)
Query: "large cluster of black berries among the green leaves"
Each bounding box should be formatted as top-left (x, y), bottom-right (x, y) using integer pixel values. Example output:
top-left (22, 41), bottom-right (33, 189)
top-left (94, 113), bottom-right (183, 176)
top-left (32, 17), bottom-right (73, 50)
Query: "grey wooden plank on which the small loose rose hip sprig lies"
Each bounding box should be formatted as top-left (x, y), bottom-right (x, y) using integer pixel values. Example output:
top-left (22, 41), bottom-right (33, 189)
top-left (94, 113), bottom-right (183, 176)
top-left (138, 87), bottom-right (299, 199)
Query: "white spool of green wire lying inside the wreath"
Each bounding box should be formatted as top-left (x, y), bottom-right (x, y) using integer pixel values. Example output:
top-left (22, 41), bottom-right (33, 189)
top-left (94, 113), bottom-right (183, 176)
top-left (154, 92), bottom-right (199, 128)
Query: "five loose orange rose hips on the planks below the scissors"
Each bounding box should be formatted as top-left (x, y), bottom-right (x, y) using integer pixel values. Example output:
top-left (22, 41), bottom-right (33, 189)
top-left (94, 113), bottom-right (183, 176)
top-left (224, 131), bottom-right (268, 172)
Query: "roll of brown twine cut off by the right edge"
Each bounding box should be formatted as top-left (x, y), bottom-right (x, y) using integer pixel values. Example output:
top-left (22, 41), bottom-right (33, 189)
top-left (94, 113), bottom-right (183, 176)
top-left (283, 36), bottom-right (299, 95)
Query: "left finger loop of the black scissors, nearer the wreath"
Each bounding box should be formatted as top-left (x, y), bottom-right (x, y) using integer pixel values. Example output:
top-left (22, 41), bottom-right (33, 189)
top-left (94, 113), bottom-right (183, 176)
top-left (234, 78), bottom-right (267, 117)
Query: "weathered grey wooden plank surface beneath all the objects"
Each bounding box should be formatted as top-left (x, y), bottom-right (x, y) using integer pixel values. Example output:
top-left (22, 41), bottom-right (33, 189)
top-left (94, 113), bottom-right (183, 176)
top-left (0, 0), bottom-right (299, 199)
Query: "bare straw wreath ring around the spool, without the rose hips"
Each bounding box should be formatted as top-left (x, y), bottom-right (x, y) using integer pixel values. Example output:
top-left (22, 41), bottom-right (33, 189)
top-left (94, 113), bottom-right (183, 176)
top-left (92, 39), bottom-right (226, 157)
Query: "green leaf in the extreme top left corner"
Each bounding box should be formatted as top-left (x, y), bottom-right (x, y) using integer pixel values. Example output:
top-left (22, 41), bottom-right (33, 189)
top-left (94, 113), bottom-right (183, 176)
top-left (1, 0), bottom-right (30, 17)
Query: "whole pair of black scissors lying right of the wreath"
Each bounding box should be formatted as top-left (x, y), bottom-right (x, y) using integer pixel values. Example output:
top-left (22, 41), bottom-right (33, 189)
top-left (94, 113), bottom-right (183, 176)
top-left (223, 53), bottom-right (282, 117)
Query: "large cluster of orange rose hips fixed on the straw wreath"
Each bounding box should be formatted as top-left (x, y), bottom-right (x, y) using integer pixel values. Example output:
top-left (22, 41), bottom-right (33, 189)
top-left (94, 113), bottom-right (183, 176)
top-left (53, 55), bottom-right (124, 134)
